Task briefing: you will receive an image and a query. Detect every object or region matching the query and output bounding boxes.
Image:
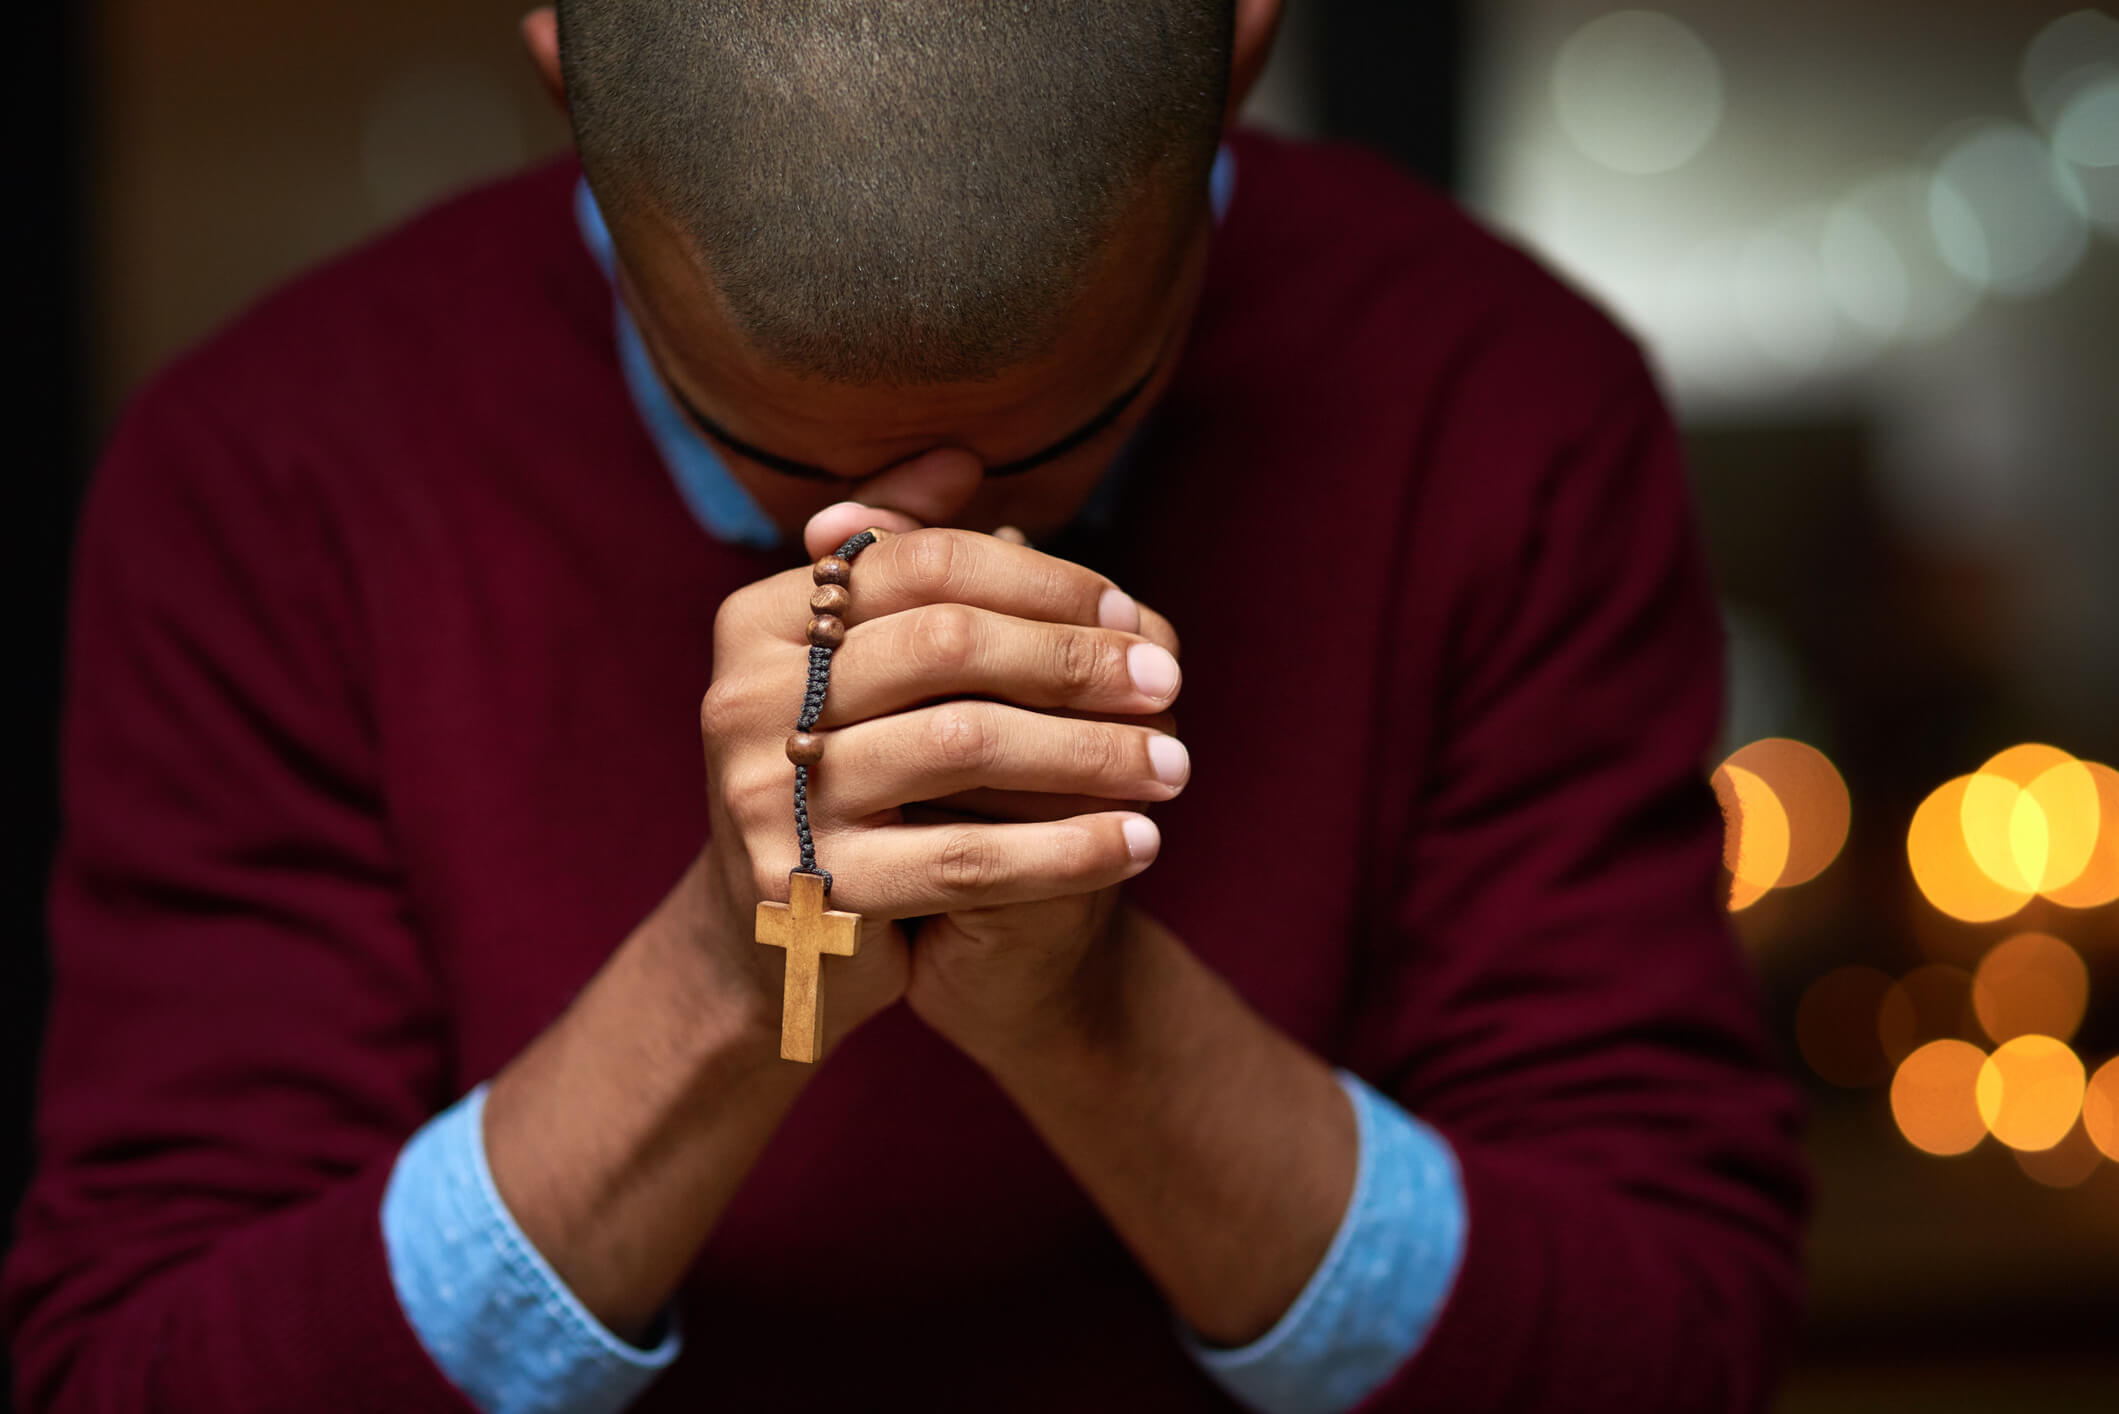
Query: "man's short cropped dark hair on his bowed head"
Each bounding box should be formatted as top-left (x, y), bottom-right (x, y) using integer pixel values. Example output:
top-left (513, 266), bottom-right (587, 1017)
top-left (559, 0), bottom-right (1233, 384)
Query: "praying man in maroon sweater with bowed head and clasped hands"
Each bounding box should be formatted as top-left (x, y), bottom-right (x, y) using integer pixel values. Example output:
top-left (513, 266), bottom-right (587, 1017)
top-left (6, 0), bottom-right (1803, 1414)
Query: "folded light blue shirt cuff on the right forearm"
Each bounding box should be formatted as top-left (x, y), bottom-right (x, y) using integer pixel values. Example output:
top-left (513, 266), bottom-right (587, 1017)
top-left (1178, 1071), bottom-right (1466, 1414)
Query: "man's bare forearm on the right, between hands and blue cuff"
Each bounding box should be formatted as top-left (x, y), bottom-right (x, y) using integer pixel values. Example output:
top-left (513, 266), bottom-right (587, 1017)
top-left (977, 909), bottom-right (1358, 1346)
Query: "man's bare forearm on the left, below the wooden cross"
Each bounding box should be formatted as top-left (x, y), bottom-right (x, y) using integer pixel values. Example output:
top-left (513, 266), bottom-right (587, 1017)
top-left (485, 847), bottom-right (814, 1338)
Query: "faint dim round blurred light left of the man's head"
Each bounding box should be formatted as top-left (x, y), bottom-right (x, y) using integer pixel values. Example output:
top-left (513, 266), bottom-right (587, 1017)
top-left (360, 64), bottom-right (528, 220)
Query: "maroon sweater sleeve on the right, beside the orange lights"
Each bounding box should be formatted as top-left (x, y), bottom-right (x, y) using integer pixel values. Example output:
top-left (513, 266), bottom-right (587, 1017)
top-left (1350, 320), bottom-right (1808, 1414)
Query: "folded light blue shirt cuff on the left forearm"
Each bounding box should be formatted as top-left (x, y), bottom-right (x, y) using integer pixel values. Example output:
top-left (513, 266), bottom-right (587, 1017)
top-left (381, 1085), bottom-right (682, 1414)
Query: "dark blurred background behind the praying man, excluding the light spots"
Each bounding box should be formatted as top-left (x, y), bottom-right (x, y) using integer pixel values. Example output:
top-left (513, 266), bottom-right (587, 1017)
top-left (0, 0), bottom-right (2119, 1414)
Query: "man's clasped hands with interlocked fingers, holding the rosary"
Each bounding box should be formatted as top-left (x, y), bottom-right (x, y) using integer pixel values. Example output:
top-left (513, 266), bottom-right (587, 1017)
top-left (699, 511), bottom-right (1191, 1062)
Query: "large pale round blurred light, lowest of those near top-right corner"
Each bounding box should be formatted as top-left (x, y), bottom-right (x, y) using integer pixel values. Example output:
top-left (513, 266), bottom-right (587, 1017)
top-left (1928, 123), bottom-right (2089, 295)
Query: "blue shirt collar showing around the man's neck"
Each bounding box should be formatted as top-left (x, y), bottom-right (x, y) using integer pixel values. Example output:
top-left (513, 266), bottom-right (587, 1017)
top-left (574, 144), bottom-right (1235, 549)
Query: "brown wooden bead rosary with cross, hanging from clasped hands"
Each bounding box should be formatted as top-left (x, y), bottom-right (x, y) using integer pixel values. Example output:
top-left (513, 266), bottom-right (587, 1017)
top-left (759, 528), bottom-right (886, 1064)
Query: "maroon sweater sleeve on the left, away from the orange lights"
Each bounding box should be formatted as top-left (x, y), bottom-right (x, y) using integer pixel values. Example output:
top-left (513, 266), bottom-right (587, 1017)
top-left (0, 365), bottom-right (473, 1414)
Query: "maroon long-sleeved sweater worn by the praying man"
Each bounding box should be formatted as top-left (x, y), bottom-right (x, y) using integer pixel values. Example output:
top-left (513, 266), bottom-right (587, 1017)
top-left (4, 138), bottom-right (1805, 1414)
